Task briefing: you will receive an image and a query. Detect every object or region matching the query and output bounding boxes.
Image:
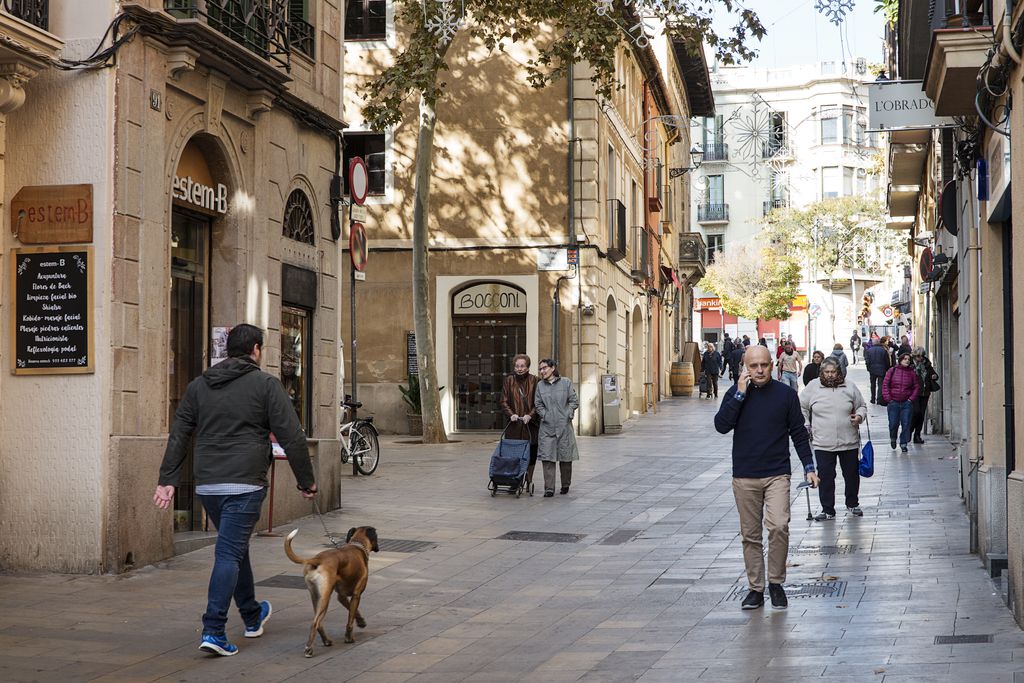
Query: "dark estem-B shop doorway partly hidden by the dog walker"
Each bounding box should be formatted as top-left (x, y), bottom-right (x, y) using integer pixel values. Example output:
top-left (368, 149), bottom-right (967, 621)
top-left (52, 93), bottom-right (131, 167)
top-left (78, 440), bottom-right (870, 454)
top-left (169, 208), bottom-right (210, 531)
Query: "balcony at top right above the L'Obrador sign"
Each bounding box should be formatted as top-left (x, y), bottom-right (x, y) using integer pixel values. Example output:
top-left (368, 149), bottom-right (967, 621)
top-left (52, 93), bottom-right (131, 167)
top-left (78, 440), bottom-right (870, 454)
top-left (925, 0), bottom-right (992, 116)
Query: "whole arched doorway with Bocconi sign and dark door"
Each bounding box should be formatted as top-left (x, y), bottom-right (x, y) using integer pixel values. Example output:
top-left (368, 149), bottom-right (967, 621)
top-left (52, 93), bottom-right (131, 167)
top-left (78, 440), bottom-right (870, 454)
top-left (452, 282), bottom-right (537, 430)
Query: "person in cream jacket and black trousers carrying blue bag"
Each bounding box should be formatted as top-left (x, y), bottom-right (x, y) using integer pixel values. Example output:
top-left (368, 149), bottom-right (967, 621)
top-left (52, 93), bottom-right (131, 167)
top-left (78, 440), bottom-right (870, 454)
top-left (800, 358), bottom-right (867, 521)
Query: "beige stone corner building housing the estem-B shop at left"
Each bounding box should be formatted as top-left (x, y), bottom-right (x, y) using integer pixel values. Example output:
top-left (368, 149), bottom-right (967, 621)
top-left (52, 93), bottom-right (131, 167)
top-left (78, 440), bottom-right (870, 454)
top-left (0, 0), bottom-right (343, 572)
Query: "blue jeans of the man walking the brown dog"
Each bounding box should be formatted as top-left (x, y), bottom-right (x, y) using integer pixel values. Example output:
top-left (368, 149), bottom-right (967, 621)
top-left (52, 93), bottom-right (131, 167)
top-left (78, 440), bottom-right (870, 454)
top-left (200, 488), bottom-right (266, 636)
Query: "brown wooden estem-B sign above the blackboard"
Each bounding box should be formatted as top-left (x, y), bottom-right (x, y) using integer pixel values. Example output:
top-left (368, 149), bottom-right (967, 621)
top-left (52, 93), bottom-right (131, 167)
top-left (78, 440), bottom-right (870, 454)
top-left (10, 184), bottom-right (93, 245)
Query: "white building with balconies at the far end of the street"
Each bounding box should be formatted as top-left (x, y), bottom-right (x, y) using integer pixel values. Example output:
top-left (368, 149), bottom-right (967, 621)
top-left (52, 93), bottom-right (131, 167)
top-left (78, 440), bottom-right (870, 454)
top-left (692, 58), bottom-right (881, 352)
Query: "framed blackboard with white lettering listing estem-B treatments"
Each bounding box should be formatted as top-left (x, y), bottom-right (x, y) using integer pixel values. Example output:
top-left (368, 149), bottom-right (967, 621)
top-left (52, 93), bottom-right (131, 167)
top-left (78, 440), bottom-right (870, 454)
top-left (10, 247), bottom-right (93, 375)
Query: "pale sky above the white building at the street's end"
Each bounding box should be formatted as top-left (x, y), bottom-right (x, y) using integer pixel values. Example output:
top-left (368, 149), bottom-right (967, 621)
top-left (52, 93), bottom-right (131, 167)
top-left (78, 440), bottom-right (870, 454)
top-left (716, 0), bottom-right (885, 69)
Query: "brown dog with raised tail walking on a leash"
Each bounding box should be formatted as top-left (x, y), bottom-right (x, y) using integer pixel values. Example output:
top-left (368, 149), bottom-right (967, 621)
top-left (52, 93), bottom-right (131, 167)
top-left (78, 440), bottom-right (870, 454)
top-left (285, 526), bottom-right (380, 657)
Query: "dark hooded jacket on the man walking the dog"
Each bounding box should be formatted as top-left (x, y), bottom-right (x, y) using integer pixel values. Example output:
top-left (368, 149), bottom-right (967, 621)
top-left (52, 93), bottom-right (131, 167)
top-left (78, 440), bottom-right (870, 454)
top-left (160, 357), bottom-right (314, 488)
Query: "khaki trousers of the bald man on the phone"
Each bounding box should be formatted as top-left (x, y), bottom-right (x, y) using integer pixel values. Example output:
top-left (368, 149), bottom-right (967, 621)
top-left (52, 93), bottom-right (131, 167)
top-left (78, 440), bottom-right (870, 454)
top-left (732, 474), bottom-right (790, 593)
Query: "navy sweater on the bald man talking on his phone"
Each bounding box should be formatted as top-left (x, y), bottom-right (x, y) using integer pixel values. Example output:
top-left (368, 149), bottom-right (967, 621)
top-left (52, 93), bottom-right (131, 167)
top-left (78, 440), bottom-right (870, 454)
top-left (715, 380), bottom-right (814, 479)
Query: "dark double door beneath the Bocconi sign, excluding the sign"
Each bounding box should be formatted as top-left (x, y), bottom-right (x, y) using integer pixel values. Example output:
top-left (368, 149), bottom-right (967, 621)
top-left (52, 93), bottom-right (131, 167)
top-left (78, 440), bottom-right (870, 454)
top-left (453, 314), bottom-right (524, 430)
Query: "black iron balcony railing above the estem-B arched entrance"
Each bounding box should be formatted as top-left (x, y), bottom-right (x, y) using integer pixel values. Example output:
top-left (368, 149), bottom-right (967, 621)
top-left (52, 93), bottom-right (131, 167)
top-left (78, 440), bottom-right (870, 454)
top-left (164, 0), bottom-right (314, 69)
